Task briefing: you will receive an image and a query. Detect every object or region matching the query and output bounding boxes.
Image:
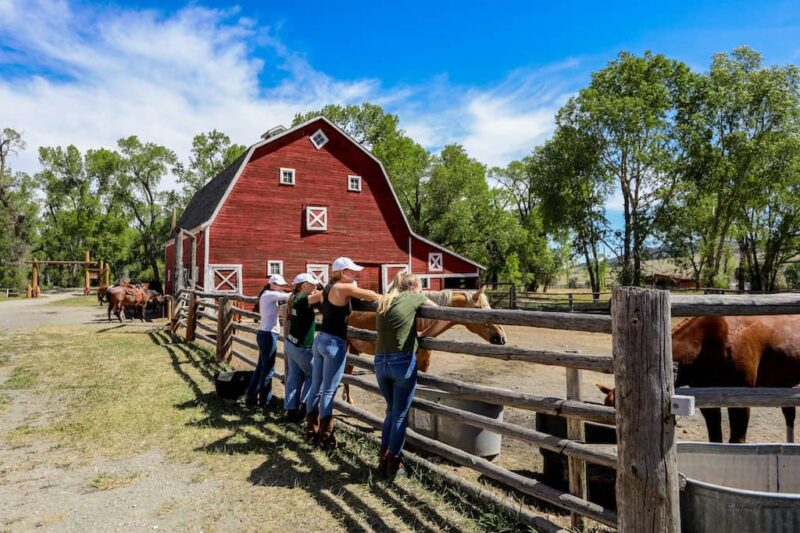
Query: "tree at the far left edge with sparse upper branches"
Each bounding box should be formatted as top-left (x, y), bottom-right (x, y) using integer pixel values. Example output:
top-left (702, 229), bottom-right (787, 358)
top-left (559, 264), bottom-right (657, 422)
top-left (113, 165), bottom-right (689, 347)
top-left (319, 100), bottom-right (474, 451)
top-left (0, 128), bottom-right (37, 287)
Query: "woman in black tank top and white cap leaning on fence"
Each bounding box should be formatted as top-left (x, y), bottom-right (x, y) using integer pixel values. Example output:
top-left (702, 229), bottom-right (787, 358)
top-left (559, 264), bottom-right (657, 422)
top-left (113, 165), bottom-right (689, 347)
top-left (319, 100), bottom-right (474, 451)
top-left (306, 257), bottom-right (381, 449)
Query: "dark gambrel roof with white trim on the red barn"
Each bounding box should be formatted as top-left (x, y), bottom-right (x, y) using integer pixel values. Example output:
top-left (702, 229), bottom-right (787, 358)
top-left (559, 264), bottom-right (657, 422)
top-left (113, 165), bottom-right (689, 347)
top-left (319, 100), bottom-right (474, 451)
top-left (173, 115), bottom-right (486, 270)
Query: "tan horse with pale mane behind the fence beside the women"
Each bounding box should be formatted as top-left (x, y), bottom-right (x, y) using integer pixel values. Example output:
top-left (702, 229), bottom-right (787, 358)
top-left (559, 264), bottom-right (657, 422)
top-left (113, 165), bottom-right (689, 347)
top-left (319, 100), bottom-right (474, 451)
top-left (343, 288), bottom-right (506, 403)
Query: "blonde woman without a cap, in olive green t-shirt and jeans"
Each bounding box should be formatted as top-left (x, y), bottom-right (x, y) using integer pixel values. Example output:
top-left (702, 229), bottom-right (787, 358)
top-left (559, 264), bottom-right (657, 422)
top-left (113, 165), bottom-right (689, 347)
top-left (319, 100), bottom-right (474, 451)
top-left (375, 272), bottom-right (449, 477)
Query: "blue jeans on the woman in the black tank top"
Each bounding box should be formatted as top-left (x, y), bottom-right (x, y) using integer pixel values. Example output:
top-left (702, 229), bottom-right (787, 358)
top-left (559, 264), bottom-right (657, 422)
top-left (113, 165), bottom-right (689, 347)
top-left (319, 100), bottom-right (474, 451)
top-left (306, 331), bottom-right (347, 418)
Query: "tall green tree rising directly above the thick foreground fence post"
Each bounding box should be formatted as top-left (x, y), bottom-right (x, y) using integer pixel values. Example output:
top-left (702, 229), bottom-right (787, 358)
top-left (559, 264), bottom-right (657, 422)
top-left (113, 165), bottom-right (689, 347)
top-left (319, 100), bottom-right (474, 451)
top-left (559, 52), bottom-right (689, 285)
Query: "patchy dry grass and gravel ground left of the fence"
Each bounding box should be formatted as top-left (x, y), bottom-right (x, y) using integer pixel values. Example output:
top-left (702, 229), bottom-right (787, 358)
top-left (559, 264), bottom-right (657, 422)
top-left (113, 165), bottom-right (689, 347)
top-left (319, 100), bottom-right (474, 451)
top-left (0, 298), bottom-right (536, 531)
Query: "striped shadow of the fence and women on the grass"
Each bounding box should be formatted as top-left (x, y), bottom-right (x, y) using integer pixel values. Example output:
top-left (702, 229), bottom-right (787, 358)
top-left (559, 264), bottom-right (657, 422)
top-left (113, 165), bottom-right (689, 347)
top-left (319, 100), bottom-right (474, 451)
top-left (148, 330), bottom-right (468, 532)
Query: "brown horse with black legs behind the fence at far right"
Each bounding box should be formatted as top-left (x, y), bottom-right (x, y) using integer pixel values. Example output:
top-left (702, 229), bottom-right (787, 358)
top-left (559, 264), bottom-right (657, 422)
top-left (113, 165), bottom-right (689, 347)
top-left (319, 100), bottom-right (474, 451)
top-left (601, 315), bottom-right (800, 443)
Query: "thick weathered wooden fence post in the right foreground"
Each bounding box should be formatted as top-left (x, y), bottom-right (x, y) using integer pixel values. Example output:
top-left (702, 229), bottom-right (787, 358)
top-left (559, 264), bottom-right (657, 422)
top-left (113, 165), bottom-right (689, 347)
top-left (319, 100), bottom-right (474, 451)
top-left (611, 287), bottom-right (681, 533)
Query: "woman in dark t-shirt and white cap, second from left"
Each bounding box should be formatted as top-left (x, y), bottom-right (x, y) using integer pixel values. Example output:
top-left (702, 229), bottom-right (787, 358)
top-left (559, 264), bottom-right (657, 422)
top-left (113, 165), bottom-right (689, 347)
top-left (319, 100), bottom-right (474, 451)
top-left (283, 273), bottom-right (319, 422)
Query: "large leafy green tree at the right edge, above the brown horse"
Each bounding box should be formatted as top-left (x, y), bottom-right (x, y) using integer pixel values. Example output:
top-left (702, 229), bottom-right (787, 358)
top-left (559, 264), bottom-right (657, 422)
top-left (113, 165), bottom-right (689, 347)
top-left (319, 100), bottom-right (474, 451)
top-left (676, 47), bottom-right (800, 284)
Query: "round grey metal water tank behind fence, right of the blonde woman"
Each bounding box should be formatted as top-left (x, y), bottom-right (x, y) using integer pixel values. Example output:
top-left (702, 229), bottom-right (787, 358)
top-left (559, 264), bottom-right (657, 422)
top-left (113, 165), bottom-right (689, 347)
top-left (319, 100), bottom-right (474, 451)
top-left (408, 386), bottom-right (503, 461)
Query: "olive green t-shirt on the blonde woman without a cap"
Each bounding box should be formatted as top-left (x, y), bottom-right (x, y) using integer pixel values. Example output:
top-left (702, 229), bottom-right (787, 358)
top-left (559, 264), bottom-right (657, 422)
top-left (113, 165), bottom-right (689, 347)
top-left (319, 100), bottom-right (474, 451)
top-left (375, 292), bottom-right (428, 353)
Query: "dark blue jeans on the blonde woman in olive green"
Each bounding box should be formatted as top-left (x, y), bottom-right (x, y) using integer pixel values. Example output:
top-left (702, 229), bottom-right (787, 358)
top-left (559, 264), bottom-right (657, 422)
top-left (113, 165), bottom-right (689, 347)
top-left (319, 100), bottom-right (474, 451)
top-left (375, 352), bottom-right (417, 456)
